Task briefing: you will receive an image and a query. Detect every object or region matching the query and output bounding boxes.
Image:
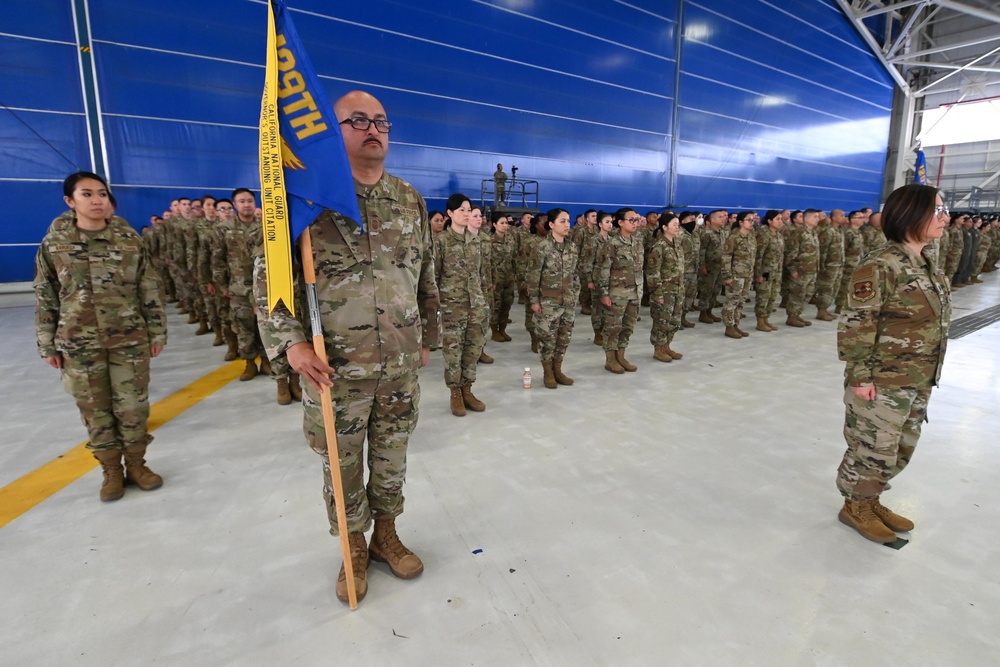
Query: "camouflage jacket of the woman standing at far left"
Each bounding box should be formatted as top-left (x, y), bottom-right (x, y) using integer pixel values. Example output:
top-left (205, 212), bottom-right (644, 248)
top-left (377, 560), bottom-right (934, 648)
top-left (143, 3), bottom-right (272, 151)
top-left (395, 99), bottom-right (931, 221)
top-left (34, 216), bottom-right (167, 357)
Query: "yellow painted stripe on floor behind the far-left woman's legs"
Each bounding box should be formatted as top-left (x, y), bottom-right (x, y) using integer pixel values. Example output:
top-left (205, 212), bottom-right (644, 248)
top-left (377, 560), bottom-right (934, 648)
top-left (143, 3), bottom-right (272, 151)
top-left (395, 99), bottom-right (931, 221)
top-left (0, 361), bottom-right (243, 528)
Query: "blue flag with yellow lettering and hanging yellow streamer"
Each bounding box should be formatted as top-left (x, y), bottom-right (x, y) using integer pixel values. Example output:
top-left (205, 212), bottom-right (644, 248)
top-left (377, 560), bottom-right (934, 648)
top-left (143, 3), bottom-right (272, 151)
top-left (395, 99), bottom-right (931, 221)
top-left (260, 0), bottom-right (361, 314)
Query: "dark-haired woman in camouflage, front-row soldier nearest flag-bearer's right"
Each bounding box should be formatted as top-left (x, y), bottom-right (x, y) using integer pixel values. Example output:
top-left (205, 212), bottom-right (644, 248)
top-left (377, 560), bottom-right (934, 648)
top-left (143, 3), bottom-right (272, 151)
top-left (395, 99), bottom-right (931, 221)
top-left (434, 194), bottom-right (489, 417)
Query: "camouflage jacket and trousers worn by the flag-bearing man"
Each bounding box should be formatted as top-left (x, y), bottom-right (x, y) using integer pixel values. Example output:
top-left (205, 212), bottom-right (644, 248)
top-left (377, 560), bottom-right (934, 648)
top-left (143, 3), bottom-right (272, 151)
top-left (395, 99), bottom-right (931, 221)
top-left (254, 173), bottom-right (439, 534)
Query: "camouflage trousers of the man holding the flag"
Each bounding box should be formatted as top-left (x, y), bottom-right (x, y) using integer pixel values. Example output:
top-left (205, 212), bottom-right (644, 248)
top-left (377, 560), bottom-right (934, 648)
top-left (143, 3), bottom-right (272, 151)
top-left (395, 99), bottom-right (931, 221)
top-left (302, 372), bottom-right (420, 535)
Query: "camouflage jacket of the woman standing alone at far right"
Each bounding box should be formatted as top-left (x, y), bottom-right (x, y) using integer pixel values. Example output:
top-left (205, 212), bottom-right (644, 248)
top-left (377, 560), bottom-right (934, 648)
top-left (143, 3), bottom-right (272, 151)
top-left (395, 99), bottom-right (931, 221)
top-left (837, 243), bottom-right (951, 388)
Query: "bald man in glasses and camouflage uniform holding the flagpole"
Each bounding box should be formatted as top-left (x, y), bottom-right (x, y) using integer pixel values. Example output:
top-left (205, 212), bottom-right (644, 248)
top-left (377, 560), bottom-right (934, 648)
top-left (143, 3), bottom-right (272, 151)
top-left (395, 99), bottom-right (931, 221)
top-left (256, 92), bottom-right (438, 602)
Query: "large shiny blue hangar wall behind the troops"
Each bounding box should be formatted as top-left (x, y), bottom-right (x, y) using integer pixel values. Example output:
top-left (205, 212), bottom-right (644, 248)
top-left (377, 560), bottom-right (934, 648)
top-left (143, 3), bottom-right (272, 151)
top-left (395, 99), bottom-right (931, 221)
top-left (0, 0), bottom-right (892, 281)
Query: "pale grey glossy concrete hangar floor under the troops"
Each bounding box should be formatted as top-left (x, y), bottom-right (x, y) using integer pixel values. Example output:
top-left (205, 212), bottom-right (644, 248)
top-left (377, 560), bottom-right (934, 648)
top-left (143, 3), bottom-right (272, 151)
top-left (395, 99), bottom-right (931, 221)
top-left (0, 273), bottom-right (1000, 667)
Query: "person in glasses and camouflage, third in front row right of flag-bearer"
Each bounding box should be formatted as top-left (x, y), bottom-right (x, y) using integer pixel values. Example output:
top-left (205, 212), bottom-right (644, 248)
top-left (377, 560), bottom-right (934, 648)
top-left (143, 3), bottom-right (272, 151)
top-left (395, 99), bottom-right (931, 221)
top-left (594, 208), bottom-right (643, 374)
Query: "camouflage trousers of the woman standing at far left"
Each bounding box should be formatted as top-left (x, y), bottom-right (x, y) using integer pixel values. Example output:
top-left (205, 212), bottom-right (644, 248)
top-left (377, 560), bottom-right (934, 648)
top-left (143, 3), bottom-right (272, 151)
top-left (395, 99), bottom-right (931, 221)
top-left (62, 345), bottom-right (153, 449)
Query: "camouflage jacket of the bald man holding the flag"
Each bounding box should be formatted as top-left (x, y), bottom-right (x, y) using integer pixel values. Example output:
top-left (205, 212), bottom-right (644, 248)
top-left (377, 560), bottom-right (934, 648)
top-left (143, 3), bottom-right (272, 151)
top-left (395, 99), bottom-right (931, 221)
top-left (254, 173), bottom-right (438, 380)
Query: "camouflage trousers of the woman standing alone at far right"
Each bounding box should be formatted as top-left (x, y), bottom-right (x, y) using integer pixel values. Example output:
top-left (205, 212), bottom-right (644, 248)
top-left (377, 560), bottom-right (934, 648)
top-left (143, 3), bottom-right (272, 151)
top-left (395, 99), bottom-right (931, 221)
top-left (837, 387), bottom-right (931, 500)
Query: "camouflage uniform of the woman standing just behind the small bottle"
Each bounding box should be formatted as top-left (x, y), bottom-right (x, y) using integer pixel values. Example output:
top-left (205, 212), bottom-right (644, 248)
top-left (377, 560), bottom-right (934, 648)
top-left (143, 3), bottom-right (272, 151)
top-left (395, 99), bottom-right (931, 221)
top-left (525, 236), bottom-right (580, 362)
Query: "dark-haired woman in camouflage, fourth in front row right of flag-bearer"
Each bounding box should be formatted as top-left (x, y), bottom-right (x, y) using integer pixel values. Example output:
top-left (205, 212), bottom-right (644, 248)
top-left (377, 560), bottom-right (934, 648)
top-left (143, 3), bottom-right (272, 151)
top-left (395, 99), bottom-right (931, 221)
top-left (645, 214), bottom-right (685, 363)
